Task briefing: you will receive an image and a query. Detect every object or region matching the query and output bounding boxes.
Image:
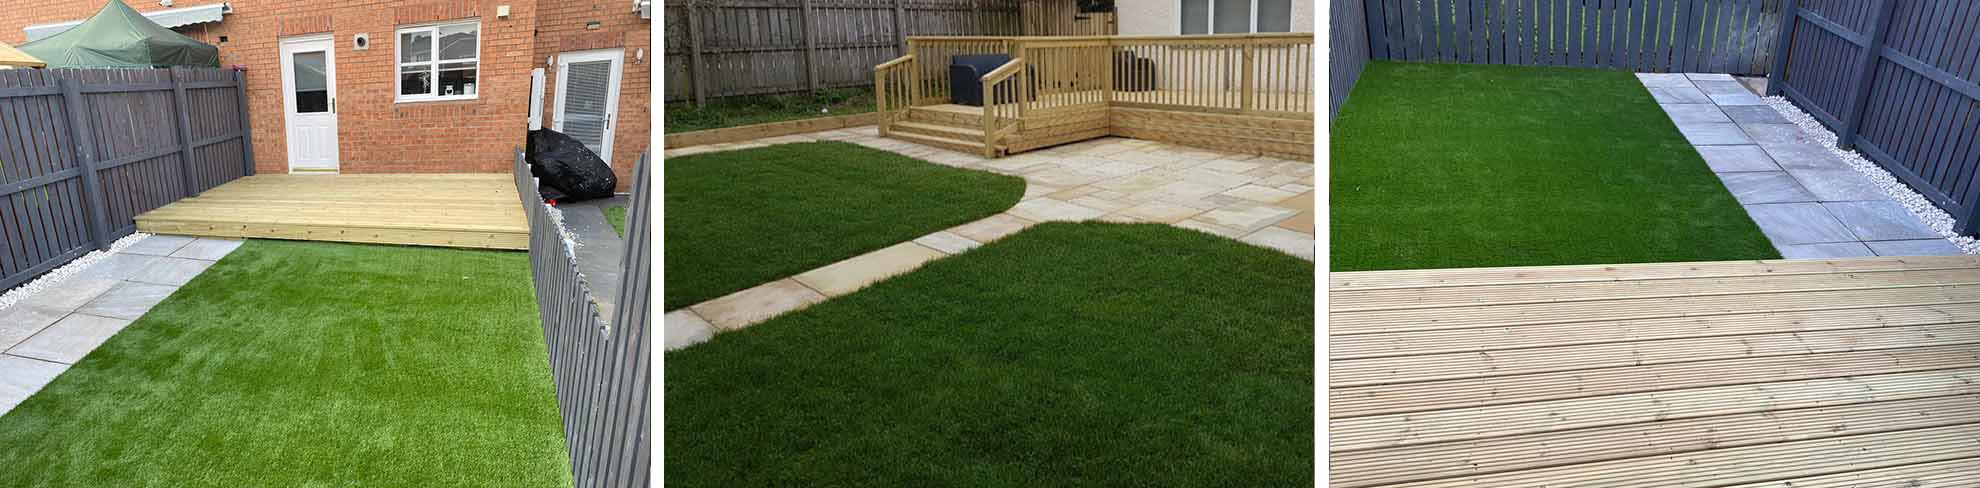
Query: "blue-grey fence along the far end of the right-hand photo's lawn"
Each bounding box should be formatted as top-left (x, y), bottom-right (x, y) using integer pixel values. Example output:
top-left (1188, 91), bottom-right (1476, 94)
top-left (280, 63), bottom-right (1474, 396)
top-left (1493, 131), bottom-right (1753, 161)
top-left (1370, 0), bottom-right (1786, 75)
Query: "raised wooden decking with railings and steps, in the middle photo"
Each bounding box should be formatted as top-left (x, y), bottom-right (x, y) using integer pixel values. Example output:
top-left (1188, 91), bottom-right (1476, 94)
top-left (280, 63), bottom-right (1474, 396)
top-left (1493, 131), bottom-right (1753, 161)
top-left (873, 34), bottom-right (1315, 159)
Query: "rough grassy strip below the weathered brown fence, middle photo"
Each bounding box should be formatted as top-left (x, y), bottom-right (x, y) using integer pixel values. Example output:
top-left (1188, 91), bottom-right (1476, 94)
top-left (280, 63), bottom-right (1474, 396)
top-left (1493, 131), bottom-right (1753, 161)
top-left (665, 87), bottom-right (873, 133)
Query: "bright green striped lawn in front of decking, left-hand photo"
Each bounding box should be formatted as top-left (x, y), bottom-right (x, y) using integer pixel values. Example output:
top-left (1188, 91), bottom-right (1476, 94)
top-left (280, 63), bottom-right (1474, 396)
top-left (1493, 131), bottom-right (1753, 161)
top-left (0, 240), bottom-right (570, 486)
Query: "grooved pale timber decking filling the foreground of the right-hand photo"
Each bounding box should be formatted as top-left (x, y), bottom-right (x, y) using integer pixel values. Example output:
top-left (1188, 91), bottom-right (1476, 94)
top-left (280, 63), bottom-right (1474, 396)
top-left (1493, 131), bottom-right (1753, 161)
top-left (1329, 256), bottom-right (1980, 488)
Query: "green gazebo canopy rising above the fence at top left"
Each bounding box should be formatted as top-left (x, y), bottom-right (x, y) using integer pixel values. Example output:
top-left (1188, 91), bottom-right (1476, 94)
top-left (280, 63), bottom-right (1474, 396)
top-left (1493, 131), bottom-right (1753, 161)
top-left (20, 0), bottom-right (220, 67)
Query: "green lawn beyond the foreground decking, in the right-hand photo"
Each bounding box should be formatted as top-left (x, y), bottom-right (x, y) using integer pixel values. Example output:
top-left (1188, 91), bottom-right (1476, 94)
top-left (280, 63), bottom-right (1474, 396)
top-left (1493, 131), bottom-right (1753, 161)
top-left (1329, 61), bottom-right (1780, 272)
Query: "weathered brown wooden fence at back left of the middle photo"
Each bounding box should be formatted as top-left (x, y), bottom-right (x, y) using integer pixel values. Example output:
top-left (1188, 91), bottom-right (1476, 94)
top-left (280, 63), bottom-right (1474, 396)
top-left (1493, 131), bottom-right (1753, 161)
top-left (661, 0), bottom-right (1024, 103)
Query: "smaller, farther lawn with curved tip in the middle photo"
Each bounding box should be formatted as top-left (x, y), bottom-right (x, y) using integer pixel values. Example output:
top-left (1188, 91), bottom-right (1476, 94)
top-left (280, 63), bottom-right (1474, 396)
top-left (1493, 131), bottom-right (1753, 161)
top-left (663, 141), bottom-right (1024, 309)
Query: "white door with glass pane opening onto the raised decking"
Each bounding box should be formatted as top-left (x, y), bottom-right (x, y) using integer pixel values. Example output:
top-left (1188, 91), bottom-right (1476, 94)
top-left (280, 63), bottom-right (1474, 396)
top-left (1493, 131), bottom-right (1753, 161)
top-left (281, 36), bottom-right (337, 173)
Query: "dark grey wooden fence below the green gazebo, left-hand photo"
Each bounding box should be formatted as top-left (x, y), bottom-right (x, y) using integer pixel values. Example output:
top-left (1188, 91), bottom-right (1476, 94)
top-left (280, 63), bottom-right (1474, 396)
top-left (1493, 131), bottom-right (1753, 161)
top-left (0, 69), bottom-right (253, 290)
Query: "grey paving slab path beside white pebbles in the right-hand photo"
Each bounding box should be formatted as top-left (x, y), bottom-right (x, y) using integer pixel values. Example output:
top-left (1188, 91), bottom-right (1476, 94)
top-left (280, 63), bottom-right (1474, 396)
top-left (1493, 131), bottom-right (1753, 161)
top-left (1637, 73), bottom-right (1962, 260)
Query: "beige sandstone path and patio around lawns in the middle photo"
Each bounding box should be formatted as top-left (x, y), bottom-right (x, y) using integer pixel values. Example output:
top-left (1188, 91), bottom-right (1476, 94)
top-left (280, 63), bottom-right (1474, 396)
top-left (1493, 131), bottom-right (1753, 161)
top-left (663, 127), bottom-right (1315, 351)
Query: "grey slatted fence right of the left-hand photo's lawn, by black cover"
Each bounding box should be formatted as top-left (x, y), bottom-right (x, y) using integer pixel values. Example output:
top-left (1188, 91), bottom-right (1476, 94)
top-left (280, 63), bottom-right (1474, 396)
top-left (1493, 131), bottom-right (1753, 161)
top-left (515, 151), bottom-right (653, 488)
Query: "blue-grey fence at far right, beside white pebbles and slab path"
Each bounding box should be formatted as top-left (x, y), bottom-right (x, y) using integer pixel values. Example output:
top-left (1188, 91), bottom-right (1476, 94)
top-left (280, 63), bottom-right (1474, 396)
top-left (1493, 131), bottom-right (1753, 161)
top-left (1768, 0), bottom-right (1980, 234)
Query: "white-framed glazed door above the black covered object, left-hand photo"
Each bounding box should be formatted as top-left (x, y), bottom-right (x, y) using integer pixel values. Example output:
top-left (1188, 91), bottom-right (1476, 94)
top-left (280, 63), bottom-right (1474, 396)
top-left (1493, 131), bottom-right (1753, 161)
top-left (550, 48), bottom-right (626, 165)
